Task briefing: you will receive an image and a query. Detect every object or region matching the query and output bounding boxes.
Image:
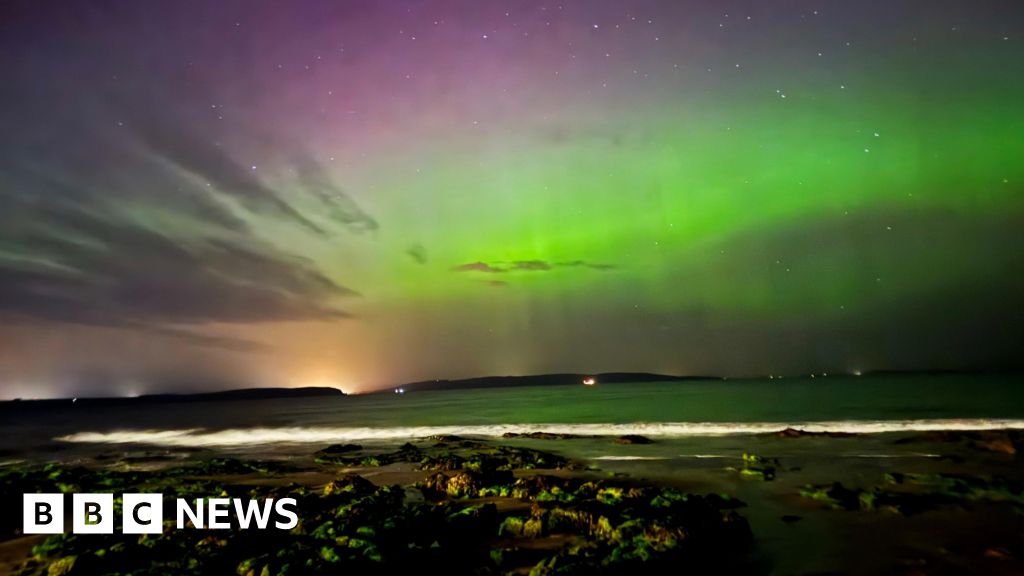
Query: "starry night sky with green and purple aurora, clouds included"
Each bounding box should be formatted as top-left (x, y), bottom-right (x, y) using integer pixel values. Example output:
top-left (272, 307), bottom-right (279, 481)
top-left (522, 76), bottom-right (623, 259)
top-left (0, 0), bottom-right (1024, 398)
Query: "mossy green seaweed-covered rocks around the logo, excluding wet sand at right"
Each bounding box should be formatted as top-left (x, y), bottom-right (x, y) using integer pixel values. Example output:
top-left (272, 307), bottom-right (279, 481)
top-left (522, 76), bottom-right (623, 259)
top-left (0, 437), bottom-right (752, 576)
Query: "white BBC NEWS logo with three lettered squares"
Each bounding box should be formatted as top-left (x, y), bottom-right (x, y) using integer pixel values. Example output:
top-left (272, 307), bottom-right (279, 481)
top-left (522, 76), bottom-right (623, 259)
top-left (22, 493), bottom-right (299, 534)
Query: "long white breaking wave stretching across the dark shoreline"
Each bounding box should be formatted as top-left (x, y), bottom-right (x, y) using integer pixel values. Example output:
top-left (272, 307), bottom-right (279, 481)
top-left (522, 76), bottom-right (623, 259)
top-left (55, 419), bottom-right (1024, 447)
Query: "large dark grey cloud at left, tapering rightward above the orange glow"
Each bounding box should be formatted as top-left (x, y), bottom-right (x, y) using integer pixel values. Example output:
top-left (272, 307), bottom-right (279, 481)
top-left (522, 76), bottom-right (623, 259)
top-left (0, 198), bottom-right (354, 334)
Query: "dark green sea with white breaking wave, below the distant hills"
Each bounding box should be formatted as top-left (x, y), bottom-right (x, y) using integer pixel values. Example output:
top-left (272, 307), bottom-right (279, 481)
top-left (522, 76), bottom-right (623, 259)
top-left (0, 375), bottom-right (1024, 459)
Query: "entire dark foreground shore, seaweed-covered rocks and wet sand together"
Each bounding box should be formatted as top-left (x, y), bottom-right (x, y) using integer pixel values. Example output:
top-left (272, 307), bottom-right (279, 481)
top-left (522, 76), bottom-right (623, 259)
top-left (0, 429), bottom-right (1024, 576)
